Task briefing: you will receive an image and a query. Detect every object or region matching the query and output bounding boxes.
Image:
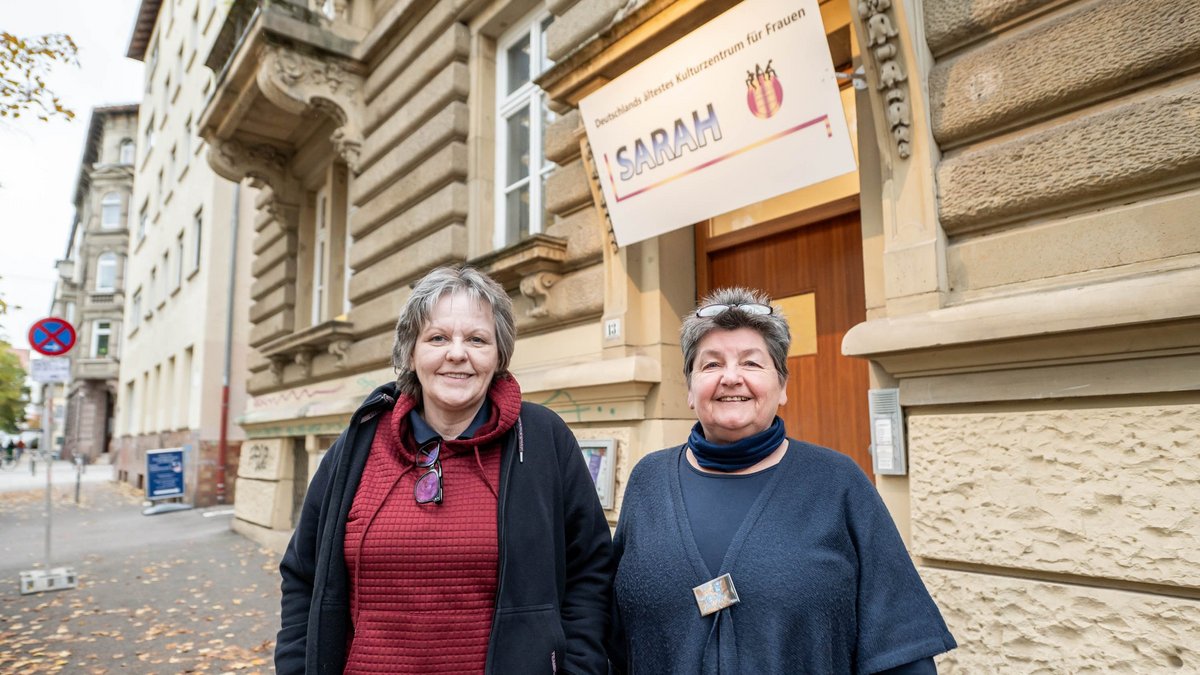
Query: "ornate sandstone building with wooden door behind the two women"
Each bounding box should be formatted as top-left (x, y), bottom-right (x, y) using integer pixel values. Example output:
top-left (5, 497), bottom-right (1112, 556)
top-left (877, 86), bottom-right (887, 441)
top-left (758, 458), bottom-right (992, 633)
top-left (199, 0), bottom-right (1200, 673)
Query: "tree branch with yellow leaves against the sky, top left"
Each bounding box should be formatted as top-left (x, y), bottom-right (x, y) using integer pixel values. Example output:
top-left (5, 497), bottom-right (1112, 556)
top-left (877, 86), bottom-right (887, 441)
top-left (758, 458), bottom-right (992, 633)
top-left (0, 31), bottom-right (79, 121)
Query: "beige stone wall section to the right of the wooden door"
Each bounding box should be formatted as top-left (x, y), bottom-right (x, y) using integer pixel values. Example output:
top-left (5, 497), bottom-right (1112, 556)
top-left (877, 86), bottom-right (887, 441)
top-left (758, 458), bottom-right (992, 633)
top-left (845, 0), bottom-right (1200, 673)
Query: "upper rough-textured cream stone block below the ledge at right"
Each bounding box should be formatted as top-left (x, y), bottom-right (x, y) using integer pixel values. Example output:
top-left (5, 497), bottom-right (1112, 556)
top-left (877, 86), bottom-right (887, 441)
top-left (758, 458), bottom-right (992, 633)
top-left (908, 405), bottom-right (1200, 589)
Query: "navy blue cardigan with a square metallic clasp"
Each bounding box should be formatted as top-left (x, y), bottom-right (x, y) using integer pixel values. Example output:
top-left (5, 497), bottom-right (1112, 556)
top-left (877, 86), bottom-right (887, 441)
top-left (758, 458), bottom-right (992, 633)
top-left (610, 440), bottom-right (956, 675)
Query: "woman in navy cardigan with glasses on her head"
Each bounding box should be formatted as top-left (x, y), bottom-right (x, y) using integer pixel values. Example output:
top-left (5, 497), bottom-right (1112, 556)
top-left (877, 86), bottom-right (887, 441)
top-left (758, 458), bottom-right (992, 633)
top-left (608, 288), bottom-right (955, 675)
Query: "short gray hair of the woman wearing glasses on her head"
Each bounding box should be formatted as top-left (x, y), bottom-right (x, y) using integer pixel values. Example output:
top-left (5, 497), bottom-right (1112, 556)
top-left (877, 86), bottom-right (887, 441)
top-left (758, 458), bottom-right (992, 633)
top-left (679, 287), bottom-right (792, 387)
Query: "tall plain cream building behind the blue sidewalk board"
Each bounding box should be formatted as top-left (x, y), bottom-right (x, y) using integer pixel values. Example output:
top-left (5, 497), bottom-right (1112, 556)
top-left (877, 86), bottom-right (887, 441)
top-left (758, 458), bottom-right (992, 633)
top-left (113, 0), bottom-right (254, 504)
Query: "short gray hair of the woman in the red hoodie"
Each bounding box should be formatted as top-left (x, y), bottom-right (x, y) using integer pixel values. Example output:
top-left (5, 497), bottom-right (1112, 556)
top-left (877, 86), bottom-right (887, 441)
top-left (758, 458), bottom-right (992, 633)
top-left (391, 265), bottom-right (517, 398)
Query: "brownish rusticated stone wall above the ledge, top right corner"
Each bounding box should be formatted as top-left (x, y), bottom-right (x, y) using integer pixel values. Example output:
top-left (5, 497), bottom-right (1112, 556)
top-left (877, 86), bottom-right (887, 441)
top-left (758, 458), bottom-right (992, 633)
top-left (923, 0), bottom-right (1200, 295)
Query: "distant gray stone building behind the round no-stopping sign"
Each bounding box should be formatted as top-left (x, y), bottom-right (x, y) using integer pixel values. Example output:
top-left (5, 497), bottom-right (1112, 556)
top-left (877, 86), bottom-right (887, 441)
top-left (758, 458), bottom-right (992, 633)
top-left (50, 104), bottom-right (138, 462)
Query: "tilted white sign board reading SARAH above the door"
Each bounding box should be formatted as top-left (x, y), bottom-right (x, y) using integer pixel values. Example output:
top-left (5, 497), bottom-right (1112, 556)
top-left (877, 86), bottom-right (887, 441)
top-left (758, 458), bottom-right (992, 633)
top-left (580, 0), bottom-right (854, 246)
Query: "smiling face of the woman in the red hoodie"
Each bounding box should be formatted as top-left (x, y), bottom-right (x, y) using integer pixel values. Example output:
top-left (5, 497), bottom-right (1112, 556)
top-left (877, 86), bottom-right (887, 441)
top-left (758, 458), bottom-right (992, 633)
top-left (413, 293), bottom-right (499, 416)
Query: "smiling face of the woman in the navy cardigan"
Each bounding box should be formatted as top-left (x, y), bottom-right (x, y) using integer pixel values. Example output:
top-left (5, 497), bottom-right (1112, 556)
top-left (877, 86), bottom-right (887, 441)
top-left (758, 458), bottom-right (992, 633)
top-left (688, 328), bottom-right (787, 443)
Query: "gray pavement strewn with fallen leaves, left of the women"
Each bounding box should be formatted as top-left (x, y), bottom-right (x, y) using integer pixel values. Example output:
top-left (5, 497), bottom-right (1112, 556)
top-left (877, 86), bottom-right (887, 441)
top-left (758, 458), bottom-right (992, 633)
top-left (0, 475), bottom-right (280, 675)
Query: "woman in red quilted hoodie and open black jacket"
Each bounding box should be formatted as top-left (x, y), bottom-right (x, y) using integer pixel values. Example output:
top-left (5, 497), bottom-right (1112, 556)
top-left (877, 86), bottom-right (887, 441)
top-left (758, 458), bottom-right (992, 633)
top-left (275, 263), bottom-right (612, 675)
